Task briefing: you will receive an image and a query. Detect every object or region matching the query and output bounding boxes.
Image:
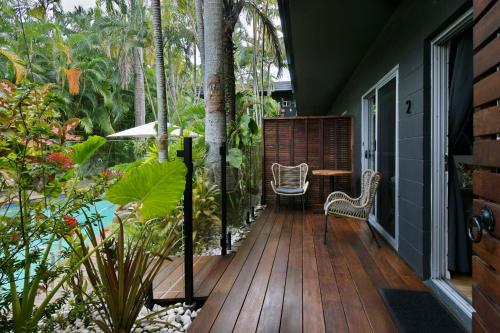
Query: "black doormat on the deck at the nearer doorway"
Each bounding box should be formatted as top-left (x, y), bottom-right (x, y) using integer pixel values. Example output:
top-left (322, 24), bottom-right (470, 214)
top-left (379, 288), bottom-right (465, 333)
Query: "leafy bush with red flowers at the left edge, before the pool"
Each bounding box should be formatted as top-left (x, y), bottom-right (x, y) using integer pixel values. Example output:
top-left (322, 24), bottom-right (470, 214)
top-left (0, 81), bottom-right (106, 333)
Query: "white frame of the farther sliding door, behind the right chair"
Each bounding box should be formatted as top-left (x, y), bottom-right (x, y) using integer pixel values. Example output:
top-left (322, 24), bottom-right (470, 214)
top-left (361, 65), bottom-right (399, 251)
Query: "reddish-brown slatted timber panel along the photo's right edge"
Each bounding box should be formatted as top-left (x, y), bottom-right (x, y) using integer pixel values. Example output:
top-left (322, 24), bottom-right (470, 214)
top-left (472, 0), bottom-right (500, 332)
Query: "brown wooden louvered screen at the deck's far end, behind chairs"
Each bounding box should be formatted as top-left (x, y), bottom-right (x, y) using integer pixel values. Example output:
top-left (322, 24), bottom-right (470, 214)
top-left (263, 116), bottom-right (354, 208)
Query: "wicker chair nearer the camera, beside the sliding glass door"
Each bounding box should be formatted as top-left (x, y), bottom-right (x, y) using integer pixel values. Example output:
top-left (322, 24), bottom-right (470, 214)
top-left (324, 170), bottom-right (382, 247)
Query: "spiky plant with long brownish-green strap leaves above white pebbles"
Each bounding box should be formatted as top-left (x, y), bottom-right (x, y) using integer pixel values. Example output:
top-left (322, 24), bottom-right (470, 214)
top-left (72, 216), bottom-right (177, 333)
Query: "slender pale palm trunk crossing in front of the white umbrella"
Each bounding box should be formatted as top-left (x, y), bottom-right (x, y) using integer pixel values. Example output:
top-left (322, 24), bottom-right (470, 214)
top-left (151, 0), bottom-right (168, 162)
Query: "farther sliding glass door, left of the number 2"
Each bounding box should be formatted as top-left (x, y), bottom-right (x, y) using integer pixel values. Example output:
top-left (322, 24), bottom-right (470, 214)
top-left (362, 67), bottom-right (398, 248)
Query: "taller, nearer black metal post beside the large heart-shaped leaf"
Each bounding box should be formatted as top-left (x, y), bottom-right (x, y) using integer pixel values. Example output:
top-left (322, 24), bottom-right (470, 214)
top-left (177, 137), bottom-right (194, 306)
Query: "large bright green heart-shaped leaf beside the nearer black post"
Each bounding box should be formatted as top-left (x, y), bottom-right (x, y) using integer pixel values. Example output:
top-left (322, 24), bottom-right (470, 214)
top-left (106, 161), bottom-right (186, 220)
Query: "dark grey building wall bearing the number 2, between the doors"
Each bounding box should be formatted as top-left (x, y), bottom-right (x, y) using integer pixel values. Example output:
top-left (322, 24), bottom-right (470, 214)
top-left (329, 0), bottom-right (472, 278)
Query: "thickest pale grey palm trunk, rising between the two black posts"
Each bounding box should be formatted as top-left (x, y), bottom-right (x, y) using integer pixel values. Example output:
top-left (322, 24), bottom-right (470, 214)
top-left (204, 0), bottom-right (226, 175)
